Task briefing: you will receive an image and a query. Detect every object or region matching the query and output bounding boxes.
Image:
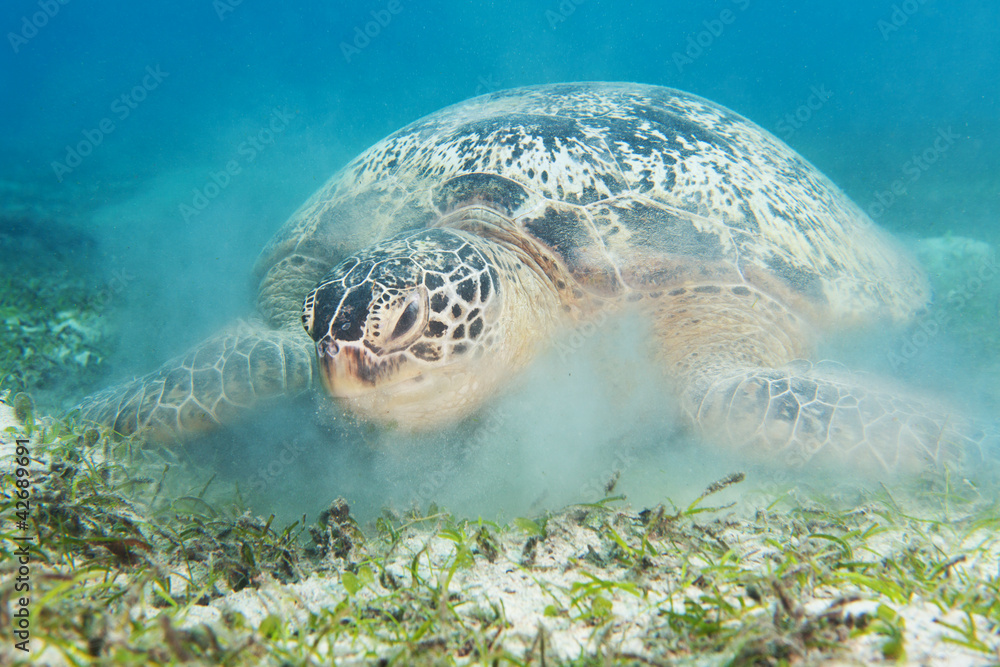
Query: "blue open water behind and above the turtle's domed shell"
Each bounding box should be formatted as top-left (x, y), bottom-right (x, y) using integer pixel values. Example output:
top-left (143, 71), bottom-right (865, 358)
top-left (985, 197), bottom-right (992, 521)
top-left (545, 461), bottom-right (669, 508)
top-left (0, 0), bottom-right (1000, 520)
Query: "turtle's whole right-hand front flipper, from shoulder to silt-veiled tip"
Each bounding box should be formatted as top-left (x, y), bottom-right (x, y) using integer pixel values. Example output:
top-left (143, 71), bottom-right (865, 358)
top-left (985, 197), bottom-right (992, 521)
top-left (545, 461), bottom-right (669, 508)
top-left (653, 285), bottom-right (992, 477)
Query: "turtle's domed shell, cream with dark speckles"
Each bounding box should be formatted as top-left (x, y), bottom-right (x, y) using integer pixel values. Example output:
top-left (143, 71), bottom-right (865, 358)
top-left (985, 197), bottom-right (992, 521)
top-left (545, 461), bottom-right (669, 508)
top-left (257, 83), bottom-right (929, 328)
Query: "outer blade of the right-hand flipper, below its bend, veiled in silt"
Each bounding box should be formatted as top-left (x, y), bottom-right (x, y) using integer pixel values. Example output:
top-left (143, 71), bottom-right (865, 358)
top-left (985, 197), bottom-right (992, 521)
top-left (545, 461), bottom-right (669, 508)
top-left (685, 361), bottom-right (986, 477)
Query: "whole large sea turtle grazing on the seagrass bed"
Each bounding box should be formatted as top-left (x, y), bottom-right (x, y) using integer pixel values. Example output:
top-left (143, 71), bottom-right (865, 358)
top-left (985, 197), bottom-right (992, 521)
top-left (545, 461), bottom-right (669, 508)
top-left (80, 83), bottom-right (981, 471)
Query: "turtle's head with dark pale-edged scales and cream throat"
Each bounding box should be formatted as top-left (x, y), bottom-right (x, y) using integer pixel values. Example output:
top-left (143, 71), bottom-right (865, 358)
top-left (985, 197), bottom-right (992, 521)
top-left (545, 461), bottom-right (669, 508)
top-left (302, 228), bottom-right (506, 428)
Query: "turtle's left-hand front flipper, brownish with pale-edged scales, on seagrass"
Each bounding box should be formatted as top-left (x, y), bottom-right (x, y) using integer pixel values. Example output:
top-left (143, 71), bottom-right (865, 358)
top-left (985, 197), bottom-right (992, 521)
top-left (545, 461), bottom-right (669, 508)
top-left (77, 322), bottom-right (315, 440)
